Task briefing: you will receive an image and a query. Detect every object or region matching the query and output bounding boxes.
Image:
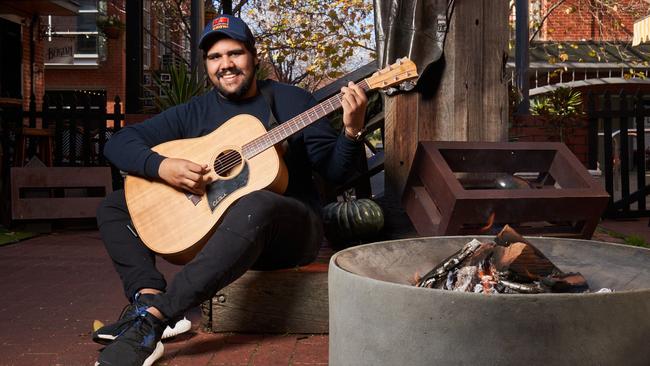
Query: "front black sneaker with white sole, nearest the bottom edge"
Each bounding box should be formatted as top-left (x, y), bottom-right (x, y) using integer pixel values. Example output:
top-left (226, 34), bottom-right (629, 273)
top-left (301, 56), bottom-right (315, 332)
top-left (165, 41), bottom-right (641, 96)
top-left (95, 311), bottom-right (167, 366)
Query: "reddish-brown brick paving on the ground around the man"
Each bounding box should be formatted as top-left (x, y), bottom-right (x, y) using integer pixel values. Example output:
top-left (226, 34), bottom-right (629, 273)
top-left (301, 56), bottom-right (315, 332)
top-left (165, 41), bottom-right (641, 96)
top-left (0, 218), bottom-right (650, 366)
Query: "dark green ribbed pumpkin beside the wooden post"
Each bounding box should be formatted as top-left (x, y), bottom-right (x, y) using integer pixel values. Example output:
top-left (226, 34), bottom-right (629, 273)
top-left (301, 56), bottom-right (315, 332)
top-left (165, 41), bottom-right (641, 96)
top-left (323, 197), bottom-right (384, 247)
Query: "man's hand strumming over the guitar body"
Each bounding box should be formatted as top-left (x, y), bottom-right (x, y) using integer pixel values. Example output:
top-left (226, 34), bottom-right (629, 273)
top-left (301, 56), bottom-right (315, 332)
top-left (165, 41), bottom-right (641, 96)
top-left (158, 158), bottom-right (210, 195)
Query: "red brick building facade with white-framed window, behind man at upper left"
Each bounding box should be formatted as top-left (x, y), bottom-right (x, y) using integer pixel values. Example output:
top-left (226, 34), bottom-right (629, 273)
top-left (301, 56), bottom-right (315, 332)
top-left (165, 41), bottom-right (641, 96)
top-left (45, 0), bottom-right (188, 113)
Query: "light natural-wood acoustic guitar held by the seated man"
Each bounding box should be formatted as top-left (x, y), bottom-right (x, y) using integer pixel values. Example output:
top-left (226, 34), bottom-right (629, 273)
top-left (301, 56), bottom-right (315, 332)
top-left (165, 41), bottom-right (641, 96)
top-left (124, 58), bottom-right (418, 264)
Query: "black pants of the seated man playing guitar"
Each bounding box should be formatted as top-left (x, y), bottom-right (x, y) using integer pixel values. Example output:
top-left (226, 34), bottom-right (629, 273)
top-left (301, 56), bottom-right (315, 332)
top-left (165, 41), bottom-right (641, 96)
top-left (97, 190), bottom-right (323, 318)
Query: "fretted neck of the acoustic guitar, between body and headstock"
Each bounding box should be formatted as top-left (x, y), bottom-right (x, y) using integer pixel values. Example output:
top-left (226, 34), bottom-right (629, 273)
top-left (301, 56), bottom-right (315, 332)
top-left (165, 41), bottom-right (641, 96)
top-left (242, 80), bottom-right (369, 159)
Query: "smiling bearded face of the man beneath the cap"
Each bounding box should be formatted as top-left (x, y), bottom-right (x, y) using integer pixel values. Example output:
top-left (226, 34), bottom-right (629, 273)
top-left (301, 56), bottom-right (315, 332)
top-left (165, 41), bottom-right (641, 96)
top-left (205, 38), bottom-right (257, 100)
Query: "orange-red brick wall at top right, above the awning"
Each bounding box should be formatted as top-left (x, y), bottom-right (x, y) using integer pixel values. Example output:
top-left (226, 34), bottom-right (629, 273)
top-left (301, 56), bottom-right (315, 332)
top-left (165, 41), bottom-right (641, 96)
top-left (541, 0), bottom-right (648, 41)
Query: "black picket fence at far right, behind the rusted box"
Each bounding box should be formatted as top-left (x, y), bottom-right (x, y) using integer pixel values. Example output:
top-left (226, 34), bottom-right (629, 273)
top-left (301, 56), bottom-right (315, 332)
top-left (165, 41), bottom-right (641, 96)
top-left (587, 91), bottom-right (650, 218)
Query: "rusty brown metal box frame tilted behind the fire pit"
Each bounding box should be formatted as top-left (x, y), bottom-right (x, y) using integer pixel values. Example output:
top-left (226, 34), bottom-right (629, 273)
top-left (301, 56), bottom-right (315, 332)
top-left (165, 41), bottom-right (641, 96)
top-left (402, 141), bottom-right (609, 239)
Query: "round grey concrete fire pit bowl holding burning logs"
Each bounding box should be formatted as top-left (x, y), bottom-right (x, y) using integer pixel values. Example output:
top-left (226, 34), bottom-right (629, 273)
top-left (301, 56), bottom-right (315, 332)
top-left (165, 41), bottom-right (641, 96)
top-left (329, 236), bottom-right (650, 366)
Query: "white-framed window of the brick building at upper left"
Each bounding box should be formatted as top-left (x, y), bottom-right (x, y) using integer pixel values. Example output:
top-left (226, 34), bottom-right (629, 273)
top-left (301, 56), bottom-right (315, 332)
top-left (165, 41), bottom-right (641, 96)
top-left (45, 0), bottom-right (106, 67)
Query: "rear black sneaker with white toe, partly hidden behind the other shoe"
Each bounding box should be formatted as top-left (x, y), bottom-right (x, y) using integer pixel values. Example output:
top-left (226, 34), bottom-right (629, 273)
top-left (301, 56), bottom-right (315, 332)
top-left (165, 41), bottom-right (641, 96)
top-left (92, 293), bottom-right (192, 345)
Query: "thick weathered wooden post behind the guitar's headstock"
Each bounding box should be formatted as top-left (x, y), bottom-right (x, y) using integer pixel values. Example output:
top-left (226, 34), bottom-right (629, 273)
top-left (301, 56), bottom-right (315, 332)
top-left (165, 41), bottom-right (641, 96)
top-left (385, 0), bottom-right (508, 197)
